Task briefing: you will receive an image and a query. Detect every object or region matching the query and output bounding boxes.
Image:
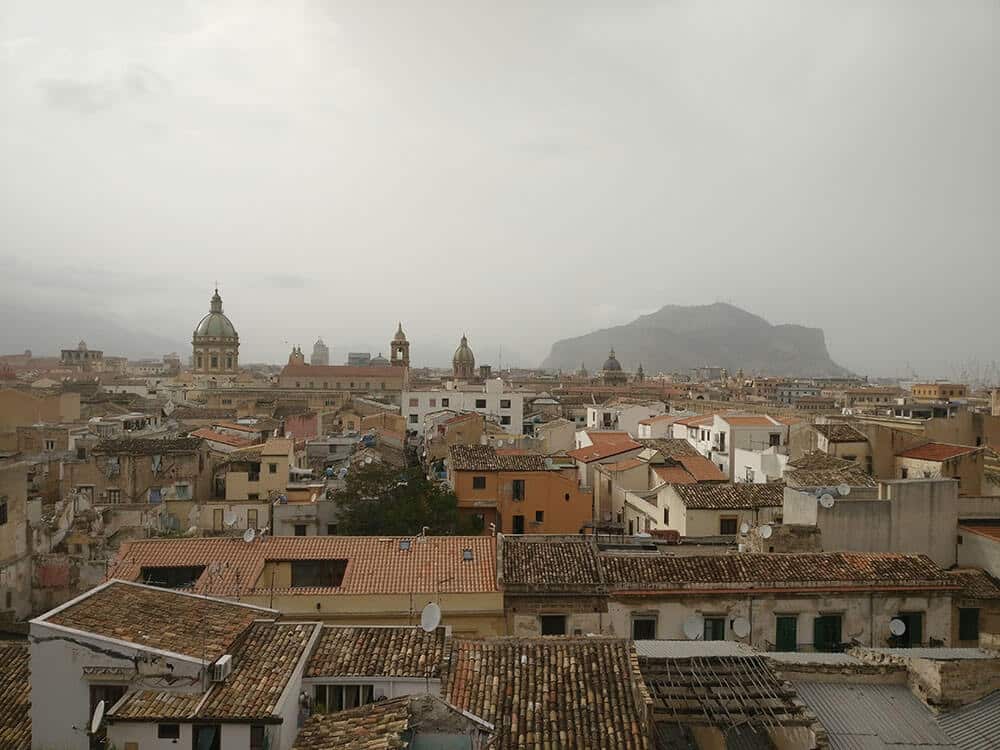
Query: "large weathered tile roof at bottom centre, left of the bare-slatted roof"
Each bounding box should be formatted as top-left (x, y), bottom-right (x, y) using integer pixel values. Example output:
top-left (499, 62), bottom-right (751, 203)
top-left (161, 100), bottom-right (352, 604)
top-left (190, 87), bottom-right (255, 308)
top-left (445, 637), bottom-right (648, 750)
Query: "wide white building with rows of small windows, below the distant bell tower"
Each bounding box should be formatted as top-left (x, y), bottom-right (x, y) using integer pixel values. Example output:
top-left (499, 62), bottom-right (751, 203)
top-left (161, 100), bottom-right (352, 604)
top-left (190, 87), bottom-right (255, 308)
top-left (402, 378), bottom-right (525, 435)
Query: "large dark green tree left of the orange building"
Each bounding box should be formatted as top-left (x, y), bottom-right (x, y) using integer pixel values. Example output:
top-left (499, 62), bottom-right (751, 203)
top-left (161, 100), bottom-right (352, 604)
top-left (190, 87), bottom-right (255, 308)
top-left (334, 463), bottom-right (482, 536)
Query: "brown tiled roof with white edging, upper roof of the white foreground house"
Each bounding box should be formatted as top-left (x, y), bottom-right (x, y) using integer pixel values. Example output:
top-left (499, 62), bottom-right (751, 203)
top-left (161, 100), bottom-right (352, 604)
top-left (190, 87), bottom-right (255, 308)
top-left (38, 584), bottom-right (276, 661)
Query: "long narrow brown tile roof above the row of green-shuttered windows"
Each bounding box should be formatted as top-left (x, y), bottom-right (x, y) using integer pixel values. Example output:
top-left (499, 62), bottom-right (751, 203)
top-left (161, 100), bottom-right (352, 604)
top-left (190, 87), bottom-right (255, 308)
top-left (601, 552), bottom-right (955, 589)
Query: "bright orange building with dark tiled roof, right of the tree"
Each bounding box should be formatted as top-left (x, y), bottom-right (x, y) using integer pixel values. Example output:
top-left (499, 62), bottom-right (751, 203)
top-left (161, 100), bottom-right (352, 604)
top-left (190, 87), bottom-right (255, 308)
top-left (448, 445), bottom-right (593, 534)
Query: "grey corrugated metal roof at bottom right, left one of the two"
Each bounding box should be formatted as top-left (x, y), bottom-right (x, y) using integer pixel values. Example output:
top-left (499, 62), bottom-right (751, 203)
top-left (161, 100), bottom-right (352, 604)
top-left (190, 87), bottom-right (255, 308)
top-left (793, 681), bottom-right (956, 750)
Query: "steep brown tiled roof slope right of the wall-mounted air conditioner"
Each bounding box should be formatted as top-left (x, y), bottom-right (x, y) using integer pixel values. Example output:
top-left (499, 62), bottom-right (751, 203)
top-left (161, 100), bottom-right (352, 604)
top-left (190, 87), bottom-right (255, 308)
top-left (198, 622), bottom-right (321, 720)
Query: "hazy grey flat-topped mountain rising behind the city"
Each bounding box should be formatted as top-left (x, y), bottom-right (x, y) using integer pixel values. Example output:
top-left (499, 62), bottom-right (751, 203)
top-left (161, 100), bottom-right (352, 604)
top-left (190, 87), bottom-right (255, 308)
top-left (542, 303), bottom-right (849, 376)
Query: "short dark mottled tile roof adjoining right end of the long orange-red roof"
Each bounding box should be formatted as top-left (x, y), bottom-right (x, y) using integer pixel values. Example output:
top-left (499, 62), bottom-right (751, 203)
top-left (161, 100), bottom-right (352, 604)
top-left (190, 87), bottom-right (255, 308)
top-left (500, 534), bottom-right (602, 590)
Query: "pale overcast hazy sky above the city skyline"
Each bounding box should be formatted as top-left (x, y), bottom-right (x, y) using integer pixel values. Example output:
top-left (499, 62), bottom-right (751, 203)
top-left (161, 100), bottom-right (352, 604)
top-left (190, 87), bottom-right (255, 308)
top-left (0, 0), bottom-right (1000, 375)
